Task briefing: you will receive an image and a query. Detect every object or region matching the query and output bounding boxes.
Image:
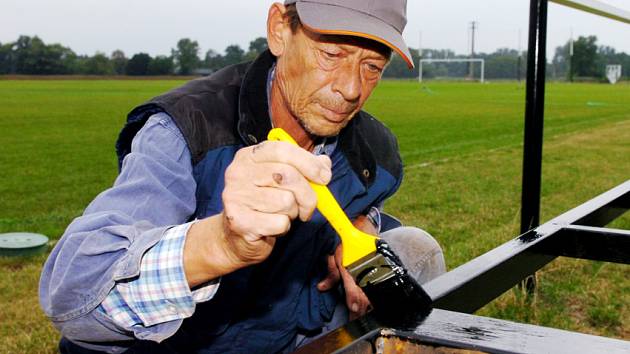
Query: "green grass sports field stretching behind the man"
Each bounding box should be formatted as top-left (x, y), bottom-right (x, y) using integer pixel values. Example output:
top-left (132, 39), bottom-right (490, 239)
top-left (0, 80), bottom-right (630, 353)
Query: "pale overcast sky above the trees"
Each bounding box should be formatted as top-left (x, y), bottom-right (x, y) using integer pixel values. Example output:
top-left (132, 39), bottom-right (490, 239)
top-left (0, 0), bottom-right (630, 55)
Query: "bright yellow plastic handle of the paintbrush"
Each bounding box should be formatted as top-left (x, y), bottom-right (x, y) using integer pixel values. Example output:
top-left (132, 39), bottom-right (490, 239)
top-left (267, 128), bottom-right (378, 267)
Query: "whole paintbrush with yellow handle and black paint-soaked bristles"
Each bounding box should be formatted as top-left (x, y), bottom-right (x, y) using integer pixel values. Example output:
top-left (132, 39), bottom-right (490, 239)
top-left (268, 128), bottom-right (431, 327)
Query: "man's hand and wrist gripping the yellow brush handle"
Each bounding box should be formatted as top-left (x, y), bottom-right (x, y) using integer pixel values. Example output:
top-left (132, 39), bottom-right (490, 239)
top-left (184, 141), bottom-right (331, 286)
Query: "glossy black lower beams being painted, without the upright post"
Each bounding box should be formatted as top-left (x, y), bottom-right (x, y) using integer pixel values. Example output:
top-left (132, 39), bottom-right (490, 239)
top-left (298, 180), bottom-right (630, 354)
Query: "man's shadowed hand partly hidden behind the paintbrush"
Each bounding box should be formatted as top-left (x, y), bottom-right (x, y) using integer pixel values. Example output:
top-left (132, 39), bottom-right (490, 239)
top-left (317, 215), bottom-right (378, 321)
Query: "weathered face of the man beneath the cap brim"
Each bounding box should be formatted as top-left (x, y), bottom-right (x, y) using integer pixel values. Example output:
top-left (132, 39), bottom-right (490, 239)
top-left (275, 28), bottom-right (389, 136)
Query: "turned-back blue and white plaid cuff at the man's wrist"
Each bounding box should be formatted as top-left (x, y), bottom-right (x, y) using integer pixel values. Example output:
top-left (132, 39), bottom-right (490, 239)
top-left (101, 222), bottom-right (219, 328)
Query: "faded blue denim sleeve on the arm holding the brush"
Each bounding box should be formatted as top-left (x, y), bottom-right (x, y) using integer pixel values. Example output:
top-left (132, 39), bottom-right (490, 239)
top-left (39, 113), bottom-right (216, 348)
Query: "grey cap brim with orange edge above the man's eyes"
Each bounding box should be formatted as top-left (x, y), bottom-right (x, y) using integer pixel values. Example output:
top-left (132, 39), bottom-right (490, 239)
top-left (296, 1), bottom-right (414, 69)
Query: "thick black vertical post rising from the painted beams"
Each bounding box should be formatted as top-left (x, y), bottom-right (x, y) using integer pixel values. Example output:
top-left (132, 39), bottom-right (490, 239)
top-left (521, 0), bottom-right (548, 293)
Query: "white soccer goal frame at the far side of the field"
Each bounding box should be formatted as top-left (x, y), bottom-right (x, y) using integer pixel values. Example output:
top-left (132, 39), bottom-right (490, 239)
top-left (418, 58), bottom-right (486, 83)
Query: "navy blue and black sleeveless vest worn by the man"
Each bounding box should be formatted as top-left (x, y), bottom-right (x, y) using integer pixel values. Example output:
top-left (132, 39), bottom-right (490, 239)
top-left (117, 52), bottom-right (402, 353)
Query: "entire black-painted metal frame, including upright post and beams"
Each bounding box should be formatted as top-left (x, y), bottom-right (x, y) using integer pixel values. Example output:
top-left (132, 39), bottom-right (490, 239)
top-left (299, 0), bottom-right (630, 348)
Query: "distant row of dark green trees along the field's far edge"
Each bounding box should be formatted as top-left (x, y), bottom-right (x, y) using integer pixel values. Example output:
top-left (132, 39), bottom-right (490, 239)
top-left (0, 36), bottom-right (630, 80)
